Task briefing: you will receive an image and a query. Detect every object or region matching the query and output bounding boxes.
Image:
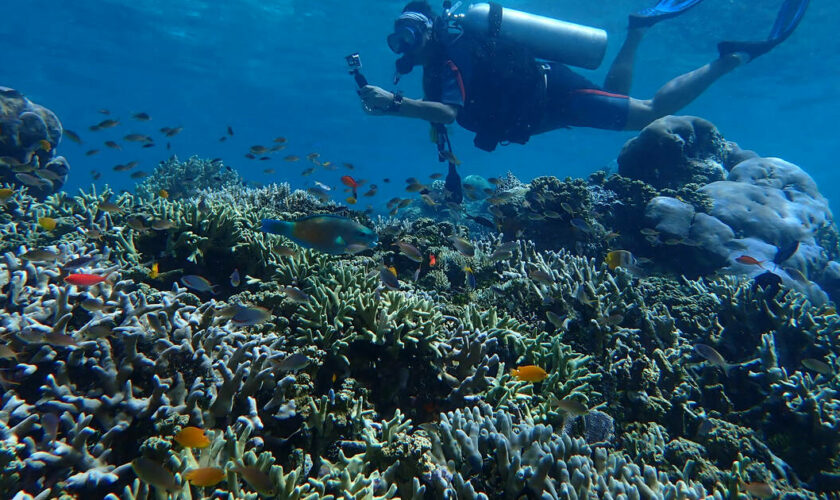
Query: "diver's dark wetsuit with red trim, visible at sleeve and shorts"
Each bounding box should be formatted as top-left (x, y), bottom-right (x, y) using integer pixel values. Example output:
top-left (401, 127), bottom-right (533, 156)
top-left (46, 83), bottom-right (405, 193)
top-left (426, 34), bottom-right (630, 134)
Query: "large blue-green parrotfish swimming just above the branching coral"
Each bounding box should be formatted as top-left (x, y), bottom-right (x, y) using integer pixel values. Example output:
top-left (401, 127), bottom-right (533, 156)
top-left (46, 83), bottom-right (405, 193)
top-left (262, 215), bottom-right (377, 255)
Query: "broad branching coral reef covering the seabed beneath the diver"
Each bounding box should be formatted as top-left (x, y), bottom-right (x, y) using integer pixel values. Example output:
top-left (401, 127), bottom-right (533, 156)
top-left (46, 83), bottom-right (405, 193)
top-left (0, 119), bottom-right (840, 500)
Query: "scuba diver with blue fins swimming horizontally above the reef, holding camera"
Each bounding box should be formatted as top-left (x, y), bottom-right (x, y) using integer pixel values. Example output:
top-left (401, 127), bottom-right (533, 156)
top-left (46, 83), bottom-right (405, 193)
top-left (358, 0), bottom-right (809, 203)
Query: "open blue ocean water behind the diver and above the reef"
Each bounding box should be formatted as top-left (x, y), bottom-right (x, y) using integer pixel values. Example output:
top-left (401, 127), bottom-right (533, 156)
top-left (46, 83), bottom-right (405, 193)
top-left (0, 0), bottom-right (840, 208)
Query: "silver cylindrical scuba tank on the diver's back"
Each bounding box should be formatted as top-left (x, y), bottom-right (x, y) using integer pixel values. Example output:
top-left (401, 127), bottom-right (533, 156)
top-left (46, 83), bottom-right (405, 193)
top-left (452, 3), bottom-right (607, 69)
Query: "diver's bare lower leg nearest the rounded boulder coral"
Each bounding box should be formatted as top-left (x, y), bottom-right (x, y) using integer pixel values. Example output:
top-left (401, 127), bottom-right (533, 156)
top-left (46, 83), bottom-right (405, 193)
top-left (625, 54), bottom-right (745, 130)
